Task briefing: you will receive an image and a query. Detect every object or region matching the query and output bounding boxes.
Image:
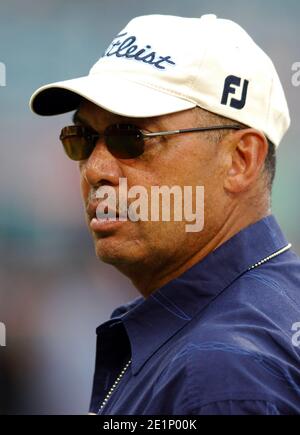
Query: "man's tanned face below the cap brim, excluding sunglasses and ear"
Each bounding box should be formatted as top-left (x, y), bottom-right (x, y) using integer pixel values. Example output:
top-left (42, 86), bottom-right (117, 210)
top-left (78, 101), bottom-right (230, 282)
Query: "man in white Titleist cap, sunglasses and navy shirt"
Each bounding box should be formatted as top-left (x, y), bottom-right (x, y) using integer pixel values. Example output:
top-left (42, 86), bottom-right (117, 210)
top-left (31, 15), bottom-right (300, 415)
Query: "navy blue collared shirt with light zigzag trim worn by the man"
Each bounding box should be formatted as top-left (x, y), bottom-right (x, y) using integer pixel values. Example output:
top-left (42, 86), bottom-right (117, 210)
top-left (90, 216), bottom-right (300, 415)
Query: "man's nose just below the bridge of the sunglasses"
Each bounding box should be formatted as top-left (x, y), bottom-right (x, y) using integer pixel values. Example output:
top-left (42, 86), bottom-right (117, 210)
top-left (81, 138), bottom-right (122, 187)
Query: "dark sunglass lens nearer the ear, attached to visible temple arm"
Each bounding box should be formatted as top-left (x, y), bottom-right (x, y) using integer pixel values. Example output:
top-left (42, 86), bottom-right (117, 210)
top-left (105, 124), bottom-right (144, 159)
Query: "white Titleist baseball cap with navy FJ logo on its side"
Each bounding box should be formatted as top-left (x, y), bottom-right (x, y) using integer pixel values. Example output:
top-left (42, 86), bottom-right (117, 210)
top-left (30, 14), bottom-right (290, 146)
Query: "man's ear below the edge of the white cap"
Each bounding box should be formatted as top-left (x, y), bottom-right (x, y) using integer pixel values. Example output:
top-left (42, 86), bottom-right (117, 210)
top-left (224, 128), bottom-right (269, 193)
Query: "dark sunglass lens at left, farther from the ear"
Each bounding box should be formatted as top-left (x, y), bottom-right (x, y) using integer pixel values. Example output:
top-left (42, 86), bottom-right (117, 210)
top-left (60, 126), bottom-right (94, 161)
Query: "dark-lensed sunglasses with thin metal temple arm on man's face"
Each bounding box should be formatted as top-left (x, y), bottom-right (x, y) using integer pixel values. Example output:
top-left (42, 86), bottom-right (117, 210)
top-left (60, 124), bottom-right (242, 161)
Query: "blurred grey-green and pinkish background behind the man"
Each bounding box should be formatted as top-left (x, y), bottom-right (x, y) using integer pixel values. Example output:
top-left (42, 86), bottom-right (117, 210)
top-left (0, 0), bottom-right (300, 414)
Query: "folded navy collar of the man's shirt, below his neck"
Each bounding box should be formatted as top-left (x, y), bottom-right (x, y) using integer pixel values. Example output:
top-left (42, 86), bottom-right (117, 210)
top-left (96, 215), bottom-right (287, 375)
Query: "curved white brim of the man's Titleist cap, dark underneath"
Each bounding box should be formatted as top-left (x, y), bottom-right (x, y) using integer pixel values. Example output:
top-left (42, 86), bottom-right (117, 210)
top-left (30, 74), bottom-right (196, 118)
